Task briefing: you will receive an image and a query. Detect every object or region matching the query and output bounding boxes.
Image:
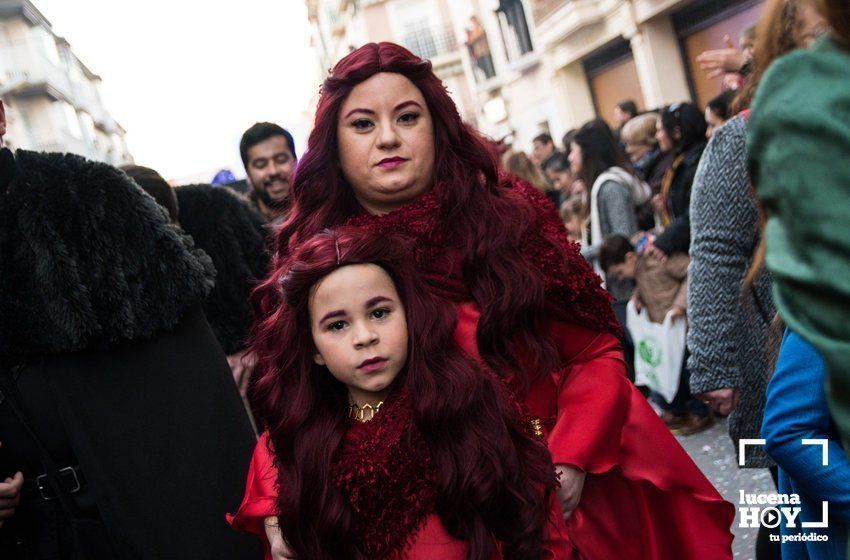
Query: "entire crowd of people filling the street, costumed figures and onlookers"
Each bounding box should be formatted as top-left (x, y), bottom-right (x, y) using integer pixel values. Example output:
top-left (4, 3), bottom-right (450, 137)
top-left (0, 0), bottom-right (850, 560)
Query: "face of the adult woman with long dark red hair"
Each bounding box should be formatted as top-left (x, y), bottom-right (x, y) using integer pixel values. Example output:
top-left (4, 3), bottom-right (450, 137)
top-left (337, 72), bottom-right (434, 214)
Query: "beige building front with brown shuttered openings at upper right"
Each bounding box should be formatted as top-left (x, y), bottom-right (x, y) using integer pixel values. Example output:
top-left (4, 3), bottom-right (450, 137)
top-left (534, 0), bottom-right (761, 138)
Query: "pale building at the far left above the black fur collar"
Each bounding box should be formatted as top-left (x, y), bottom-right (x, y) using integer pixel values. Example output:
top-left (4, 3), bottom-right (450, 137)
top-left (0, 0), bottom-right (133, 165)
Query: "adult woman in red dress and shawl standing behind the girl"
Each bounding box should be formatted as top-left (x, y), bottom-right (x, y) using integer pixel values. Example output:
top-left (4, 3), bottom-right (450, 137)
top-left (248, 43), bottom-right (734, 560)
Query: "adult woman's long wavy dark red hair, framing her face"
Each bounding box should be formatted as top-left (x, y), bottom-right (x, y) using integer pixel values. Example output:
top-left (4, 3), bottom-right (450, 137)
top-left (255, 43), bottom-right (567, 385)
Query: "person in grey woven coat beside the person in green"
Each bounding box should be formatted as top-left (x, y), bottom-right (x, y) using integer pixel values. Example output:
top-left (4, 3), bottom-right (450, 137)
top-left (688, 111), bottom-right (776, 467)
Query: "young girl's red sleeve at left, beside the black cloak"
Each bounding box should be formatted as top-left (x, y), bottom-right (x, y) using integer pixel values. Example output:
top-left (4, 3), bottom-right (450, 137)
top-left (227, 432), bottom-right (277, 550)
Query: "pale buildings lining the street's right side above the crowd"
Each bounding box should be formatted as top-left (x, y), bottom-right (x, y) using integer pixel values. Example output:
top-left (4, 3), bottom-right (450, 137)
top-left (308, 0), bottom-right (761, 150)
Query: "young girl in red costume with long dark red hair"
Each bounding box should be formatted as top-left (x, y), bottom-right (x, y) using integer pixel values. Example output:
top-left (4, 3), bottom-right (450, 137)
top-left (232, 228), bottom-right (571, 560)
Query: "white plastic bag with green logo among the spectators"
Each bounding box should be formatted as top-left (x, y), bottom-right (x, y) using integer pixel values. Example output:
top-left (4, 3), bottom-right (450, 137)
top-left (626, 301), bottom-right (687, 402)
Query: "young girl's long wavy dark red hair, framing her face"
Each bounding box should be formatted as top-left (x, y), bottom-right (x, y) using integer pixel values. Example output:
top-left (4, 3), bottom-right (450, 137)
top-left (253, 228), bottom-right (554, 560)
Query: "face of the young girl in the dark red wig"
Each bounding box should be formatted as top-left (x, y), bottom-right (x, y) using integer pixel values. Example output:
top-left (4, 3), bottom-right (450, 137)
top-left (309, 264), bottom-right (407, 406)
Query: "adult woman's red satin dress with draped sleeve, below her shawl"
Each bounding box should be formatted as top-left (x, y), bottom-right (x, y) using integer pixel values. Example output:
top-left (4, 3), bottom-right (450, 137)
top-left (549, 323), bottom-right (735, 560)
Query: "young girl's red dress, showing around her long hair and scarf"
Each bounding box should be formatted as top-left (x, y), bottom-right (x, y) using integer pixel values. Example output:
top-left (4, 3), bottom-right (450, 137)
top-left (227, 432), bottom-right (578, 560)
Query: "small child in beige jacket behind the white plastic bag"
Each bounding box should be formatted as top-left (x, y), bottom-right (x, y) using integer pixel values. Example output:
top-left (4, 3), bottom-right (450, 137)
top-left (599, 235), bottom-right (714, 435)
